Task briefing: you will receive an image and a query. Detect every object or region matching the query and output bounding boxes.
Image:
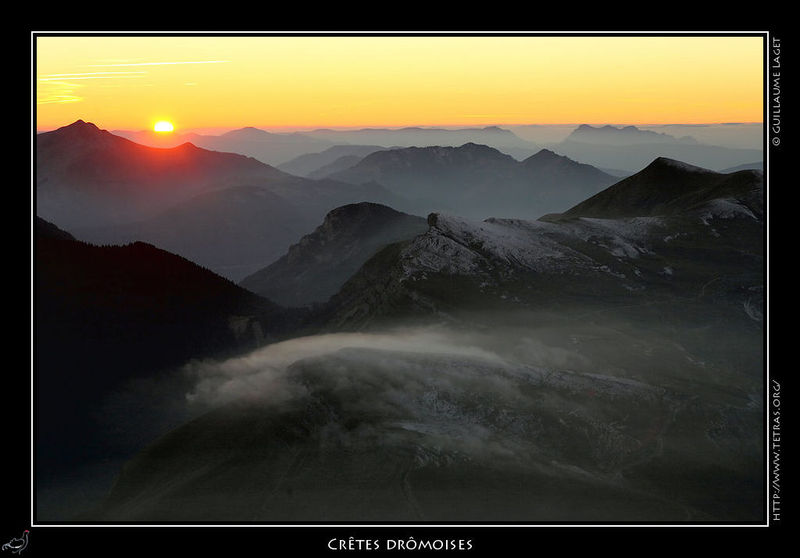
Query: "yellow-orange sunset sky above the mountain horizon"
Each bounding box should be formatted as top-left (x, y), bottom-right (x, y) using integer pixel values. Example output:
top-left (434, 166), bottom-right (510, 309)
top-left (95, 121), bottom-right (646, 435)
top-left (33, 34), bottom-right (764, 131)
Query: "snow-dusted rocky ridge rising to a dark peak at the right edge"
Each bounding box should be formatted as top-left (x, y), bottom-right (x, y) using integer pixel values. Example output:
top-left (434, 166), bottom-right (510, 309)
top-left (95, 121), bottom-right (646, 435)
top-left (320, 159), bottom-right (763, 327)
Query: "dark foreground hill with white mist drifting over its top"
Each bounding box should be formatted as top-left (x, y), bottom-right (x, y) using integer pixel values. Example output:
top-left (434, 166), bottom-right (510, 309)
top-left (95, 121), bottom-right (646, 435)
top-left (79, 308), bottom-right (763, 523)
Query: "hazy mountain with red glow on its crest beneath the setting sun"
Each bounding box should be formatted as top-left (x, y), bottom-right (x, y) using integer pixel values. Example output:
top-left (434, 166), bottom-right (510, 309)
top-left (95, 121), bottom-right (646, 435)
top-left (41, 121), bottom-right (404, 280)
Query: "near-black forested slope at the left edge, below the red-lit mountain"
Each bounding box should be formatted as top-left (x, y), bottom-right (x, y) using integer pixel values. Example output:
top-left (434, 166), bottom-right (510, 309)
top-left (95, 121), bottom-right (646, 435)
top-left (34, 219), bottom-right (298, 520)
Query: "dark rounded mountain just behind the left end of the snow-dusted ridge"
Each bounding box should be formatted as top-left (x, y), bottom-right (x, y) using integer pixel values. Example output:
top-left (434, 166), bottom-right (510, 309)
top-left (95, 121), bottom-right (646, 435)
top-left (239, 202), bottom-right (428, 306)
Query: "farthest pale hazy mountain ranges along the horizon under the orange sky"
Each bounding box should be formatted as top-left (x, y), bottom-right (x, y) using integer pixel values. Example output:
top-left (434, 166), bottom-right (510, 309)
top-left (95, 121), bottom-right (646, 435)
top-left (104, 124), bottom-right (763, 178)
